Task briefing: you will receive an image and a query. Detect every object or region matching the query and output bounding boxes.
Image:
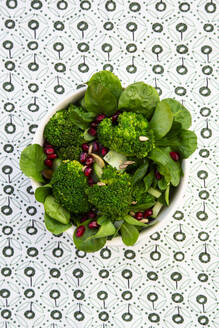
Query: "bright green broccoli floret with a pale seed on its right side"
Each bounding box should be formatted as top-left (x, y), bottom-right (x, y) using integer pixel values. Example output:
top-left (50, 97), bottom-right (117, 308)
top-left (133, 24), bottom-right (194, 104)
top-left (97, 112), bottom-right (155, 158)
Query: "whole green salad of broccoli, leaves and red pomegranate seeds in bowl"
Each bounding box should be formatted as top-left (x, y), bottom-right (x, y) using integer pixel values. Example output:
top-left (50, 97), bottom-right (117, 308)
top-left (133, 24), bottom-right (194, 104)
top-left (20, 71), bottom-right (197, 252)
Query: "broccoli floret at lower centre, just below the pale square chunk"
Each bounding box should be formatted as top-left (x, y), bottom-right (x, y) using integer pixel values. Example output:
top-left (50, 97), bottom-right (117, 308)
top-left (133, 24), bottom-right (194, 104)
top-left (86, 166), bottom-right (132, 220)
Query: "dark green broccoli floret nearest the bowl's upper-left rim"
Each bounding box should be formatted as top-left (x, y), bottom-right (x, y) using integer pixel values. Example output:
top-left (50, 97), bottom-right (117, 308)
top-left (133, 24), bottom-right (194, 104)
top-left (44, 109), bottom-right (83, 147)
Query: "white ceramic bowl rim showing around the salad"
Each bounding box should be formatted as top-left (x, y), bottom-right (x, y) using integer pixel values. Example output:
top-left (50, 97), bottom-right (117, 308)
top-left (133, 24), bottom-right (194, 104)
top-left (32, 87), bottom-right (188, 246)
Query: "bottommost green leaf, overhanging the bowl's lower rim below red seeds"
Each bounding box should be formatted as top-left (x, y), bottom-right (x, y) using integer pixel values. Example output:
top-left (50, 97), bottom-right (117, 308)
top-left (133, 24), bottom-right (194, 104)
top-left (73, 221), bottom-right (106, 252)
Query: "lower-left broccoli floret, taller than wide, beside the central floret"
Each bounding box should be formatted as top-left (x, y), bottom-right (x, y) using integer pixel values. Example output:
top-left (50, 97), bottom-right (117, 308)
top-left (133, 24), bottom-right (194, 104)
top-left (50, 160), bottom-right (90, 213)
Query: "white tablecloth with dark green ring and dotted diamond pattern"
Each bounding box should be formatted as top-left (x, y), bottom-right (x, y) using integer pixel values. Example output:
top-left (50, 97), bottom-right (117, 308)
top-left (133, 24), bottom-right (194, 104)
top-left (0, 0), bottom-right (219, 328)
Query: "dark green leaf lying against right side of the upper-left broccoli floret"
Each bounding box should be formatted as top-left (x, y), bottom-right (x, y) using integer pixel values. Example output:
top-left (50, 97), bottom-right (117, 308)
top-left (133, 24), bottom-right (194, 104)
top-left (68, 104), bottom-right (96, 130)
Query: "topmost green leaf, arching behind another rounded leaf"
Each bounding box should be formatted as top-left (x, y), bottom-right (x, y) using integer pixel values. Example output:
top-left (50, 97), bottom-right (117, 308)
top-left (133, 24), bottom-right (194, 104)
top-left (87, 71), bottom-right (122, 100)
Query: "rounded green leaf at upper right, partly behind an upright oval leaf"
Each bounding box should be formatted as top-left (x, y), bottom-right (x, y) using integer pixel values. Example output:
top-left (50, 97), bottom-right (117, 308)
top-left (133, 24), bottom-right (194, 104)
top-left (162, 98), bottom-right (192, 129)
